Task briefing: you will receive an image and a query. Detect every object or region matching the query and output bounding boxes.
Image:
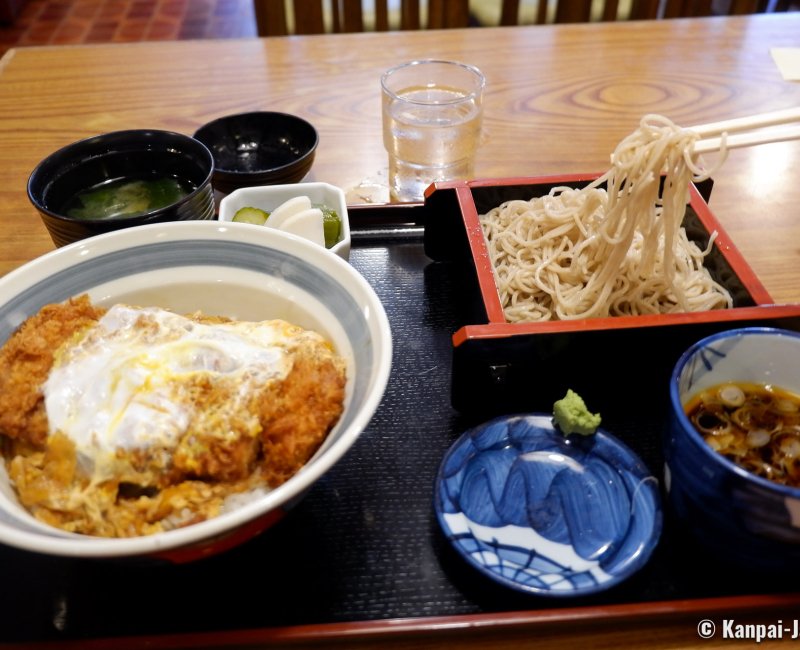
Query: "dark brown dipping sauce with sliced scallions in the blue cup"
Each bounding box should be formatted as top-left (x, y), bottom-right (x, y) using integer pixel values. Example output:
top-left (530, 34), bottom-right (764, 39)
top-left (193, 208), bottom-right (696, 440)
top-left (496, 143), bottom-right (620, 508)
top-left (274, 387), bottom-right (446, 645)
top-left (684, 383), bottom-right (800, 487)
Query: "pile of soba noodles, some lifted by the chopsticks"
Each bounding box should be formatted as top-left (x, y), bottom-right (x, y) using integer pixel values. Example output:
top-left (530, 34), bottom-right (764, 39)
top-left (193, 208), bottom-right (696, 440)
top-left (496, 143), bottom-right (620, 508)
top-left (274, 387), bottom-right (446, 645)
top-left (480, 115), bottom-right (732, 322)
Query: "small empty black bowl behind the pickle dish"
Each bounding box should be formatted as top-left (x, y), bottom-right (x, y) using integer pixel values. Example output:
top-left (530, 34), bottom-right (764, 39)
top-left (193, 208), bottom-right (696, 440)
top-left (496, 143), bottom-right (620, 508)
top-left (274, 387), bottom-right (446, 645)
top-left (194, 111), bottom-right (319, 194)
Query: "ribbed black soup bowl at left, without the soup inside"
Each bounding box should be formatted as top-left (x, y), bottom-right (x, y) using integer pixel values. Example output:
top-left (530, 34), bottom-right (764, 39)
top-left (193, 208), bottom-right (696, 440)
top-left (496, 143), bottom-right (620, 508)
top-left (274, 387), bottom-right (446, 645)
top-left (28, 129), bottom-right (215, 246)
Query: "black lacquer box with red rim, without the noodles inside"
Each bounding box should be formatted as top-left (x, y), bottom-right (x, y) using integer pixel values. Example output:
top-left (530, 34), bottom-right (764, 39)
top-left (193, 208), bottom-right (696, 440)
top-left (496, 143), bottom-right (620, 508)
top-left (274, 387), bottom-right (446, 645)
top-left (425, 174), bottom-right (800, 412)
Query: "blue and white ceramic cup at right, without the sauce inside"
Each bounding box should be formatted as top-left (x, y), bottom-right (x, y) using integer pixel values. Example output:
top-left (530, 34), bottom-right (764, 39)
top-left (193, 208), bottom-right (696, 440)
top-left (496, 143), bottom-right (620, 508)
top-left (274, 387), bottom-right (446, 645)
top-left (665, 327), bottom-right (800, 572)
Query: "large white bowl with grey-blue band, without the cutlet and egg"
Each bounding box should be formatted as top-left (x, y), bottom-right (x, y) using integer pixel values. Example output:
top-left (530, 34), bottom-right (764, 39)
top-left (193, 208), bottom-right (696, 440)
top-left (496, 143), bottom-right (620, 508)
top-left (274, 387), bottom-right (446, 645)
top-left (0, 221), bottom-right (392, 562)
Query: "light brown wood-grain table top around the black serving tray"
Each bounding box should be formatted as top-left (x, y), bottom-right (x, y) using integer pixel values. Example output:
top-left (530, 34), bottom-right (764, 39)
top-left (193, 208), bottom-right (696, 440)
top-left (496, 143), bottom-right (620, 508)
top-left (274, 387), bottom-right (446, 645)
top-left (0, 13), bottom-right (800, 649)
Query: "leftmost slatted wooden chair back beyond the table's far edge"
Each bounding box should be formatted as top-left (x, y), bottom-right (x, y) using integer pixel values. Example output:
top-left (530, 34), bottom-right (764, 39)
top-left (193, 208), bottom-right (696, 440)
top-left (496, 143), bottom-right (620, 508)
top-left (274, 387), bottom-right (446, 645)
top-left (253, 0), bottom-right (469, 36)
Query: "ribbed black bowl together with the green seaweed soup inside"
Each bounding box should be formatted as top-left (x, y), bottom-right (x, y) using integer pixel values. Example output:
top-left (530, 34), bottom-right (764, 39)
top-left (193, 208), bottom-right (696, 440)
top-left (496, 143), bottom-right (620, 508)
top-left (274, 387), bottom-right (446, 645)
top-left (28, 129), bottom-right (214, 246)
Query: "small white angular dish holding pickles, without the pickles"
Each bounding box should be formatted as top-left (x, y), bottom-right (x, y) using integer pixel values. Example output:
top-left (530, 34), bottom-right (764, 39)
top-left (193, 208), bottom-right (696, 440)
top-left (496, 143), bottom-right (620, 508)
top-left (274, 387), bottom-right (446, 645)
top-left (219, 183), bottom-right (350, 260)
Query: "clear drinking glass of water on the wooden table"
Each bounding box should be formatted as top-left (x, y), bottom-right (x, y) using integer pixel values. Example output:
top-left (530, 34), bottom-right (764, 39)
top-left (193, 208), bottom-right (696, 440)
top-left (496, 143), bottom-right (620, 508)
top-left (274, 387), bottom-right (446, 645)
top-left (381, 60), bottom-right (486, 202)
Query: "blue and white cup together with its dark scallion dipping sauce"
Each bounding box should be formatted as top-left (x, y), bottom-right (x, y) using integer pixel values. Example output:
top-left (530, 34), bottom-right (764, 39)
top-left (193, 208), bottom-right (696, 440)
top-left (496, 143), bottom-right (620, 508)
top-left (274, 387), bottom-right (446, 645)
top-left (665, 327), bottom-right (800, 576)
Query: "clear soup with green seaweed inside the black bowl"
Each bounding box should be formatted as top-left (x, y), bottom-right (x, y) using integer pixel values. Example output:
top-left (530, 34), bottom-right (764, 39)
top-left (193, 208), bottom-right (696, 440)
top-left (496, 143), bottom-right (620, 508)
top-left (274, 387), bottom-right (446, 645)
top-left (63, 177), bottom-right (196, 220)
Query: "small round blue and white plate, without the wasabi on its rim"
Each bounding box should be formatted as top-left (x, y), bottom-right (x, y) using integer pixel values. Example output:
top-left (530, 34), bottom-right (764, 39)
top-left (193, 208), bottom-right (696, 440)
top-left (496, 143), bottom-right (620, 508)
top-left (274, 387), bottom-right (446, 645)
top-left (434, 414), bottom-right (662, 597)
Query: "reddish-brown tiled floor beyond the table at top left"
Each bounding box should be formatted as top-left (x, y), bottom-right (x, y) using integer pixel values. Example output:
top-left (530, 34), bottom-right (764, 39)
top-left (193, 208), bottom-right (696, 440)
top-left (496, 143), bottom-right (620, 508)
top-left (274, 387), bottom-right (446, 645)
top-left (0, 0), bottom-right (256, 55)
